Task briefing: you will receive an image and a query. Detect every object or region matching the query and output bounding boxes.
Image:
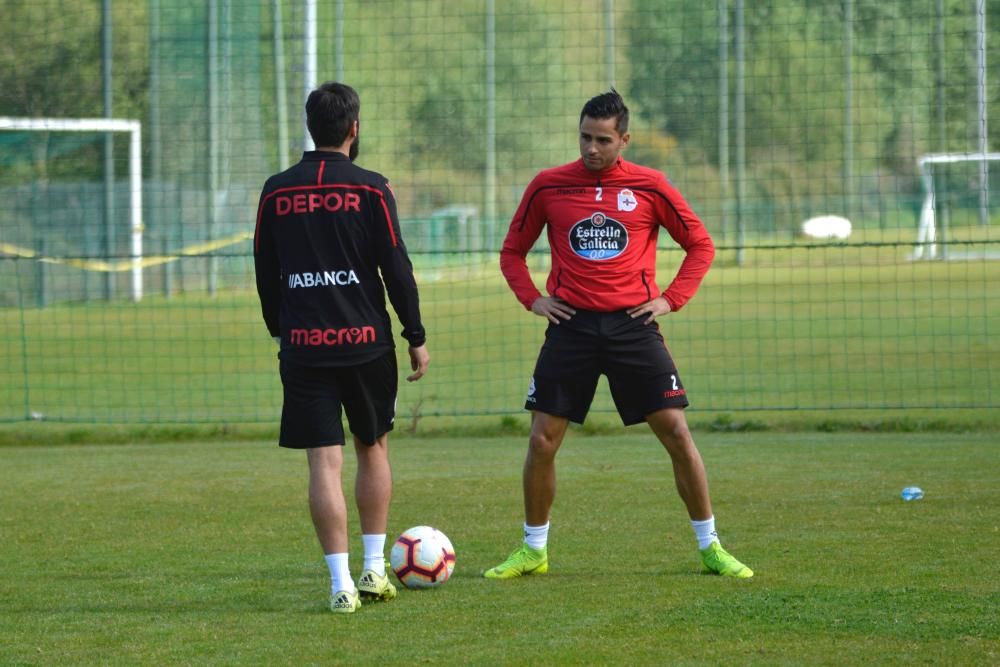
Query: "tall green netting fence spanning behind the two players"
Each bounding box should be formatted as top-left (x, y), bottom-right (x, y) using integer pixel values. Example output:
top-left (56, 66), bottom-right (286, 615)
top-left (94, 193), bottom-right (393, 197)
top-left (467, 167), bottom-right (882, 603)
top-left (0, 0), bottom-right (1000, 423)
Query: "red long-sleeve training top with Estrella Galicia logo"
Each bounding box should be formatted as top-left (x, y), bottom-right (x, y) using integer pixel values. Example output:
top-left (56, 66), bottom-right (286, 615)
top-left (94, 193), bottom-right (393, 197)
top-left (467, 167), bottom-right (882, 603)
top-left (500, 157), bottom-right (715, 312)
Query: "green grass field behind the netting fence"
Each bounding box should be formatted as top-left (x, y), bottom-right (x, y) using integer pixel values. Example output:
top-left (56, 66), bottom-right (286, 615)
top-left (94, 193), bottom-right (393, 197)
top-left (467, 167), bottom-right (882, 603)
top-left (0, 244), bottom-right (1000, 424)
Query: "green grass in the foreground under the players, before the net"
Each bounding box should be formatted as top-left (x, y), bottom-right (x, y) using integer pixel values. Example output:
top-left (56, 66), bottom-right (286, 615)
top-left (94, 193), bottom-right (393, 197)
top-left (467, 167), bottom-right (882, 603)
top-left (0, 428), bottom-right (1000, 665)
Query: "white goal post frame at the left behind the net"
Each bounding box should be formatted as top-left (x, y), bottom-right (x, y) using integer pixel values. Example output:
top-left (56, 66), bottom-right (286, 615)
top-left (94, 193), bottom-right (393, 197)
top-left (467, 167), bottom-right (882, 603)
top-left (0, 116), bottom-right (143, 301)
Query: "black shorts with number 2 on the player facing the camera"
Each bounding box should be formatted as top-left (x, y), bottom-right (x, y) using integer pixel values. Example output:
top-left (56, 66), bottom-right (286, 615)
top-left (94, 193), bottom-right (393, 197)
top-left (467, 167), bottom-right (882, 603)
top-left (524, 310), bottom-right (688, 426)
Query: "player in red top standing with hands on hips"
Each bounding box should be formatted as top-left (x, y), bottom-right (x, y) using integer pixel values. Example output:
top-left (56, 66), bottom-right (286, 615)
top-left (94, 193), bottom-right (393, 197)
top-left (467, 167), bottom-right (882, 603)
top-left (485, 89), bottom-right (753, 579)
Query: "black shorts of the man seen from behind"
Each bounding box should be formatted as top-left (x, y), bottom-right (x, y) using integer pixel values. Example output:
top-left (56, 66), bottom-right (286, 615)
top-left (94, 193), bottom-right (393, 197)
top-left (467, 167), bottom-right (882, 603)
top-left (278, 350), bottom-right (399, 449)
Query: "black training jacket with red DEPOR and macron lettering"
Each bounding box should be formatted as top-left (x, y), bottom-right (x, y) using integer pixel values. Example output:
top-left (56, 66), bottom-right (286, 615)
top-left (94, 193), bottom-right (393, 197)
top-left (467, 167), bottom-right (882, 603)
top-left (253, 151), bottom-right (426, 366)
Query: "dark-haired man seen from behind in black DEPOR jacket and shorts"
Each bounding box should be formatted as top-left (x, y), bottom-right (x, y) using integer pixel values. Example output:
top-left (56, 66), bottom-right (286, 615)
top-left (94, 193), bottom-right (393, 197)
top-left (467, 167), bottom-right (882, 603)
top-left (254, 82), bottom-right (430, 613)
